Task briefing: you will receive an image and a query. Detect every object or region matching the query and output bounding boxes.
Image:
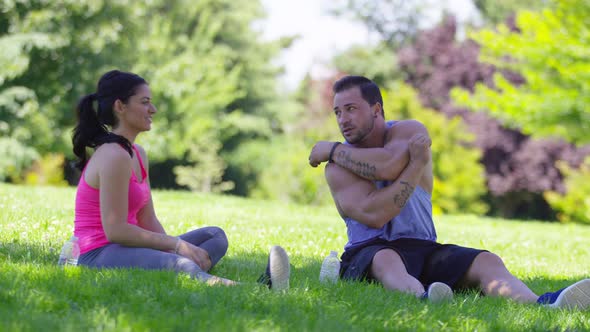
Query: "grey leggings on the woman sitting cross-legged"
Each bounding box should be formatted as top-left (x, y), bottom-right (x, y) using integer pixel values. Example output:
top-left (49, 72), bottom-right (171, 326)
top-left (78, 226), bottom-right (228, 280)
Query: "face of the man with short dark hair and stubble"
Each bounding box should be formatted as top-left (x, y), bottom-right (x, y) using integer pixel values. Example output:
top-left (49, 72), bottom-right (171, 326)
top-left (334, 87), bottom-right (375, 144)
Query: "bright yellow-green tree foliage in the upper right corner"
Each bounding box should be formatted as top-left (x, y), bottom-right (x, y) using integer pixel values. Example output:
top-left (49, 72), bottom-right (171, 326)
top-left (454, 0), bottom-right (590, 144)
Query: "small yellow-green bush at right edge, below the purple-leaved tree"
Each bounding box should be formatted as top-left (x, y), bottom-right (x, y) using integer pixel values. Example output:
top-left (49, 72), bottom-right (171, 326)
top-left (545, 157), bottom-right (590, 224)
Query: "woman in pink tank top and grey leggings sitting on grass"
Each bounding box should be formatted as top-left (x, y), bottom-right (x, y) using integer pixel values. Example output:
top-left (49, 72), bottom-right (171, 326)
top-left (72, 70), bottom-right (268, 285)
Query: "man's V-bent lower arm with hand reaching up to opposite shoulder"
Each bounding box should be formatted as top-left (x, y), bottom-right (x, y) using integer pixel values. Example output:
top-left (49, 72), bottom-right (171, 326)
top-left (326, 135), bottom-right (430, 228)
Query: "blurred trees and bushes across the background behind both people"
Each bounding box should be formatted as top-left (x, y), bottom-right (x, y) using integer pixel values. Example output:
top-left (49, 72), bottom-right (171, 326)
top-left (0, 0), bottom-right (590, 222)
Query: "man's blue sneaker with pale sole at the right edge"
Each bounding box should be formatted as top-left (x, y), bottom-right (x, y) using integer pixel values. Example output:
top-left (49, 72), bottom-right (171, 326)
top-left (537, 279), bottom-right (590, 310)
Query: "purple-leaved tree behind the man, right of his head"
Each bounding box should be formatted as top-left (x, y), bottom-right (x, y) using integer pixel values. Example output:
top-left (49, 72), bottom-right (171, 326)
top-left (398, 17), bottom-right (590, 219)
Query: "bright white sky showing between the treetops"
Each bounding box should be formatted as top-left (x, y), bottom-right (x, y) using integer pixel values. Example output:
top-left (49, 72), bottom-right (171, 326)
top-left (260, 0), bottom-right (476, 89)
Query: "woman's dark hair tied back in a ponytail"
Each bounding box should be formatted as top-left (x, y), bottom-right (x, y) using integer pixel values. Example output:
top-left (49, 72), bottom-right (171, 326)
top-left (72, 70), bottom-right (147, 170)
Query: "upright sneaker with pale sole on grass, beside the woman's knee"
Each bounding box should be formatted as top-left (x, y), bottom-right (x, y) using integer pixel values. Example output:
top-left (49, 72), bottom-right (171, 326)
top-left (258, 246), bottom-right (290, 291)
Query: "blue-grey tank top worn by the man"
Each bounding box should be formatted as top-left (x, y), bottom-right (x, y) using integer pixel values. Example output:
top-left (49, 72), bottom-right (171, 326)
top-left (343, 121), bottom-right (436, 250)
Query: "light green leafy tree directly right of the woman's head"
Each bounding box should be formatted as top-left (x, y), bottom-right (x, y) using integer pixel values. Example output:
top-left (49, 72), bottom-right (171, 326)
top-left (130, 0), bottom-right (286, 195)
